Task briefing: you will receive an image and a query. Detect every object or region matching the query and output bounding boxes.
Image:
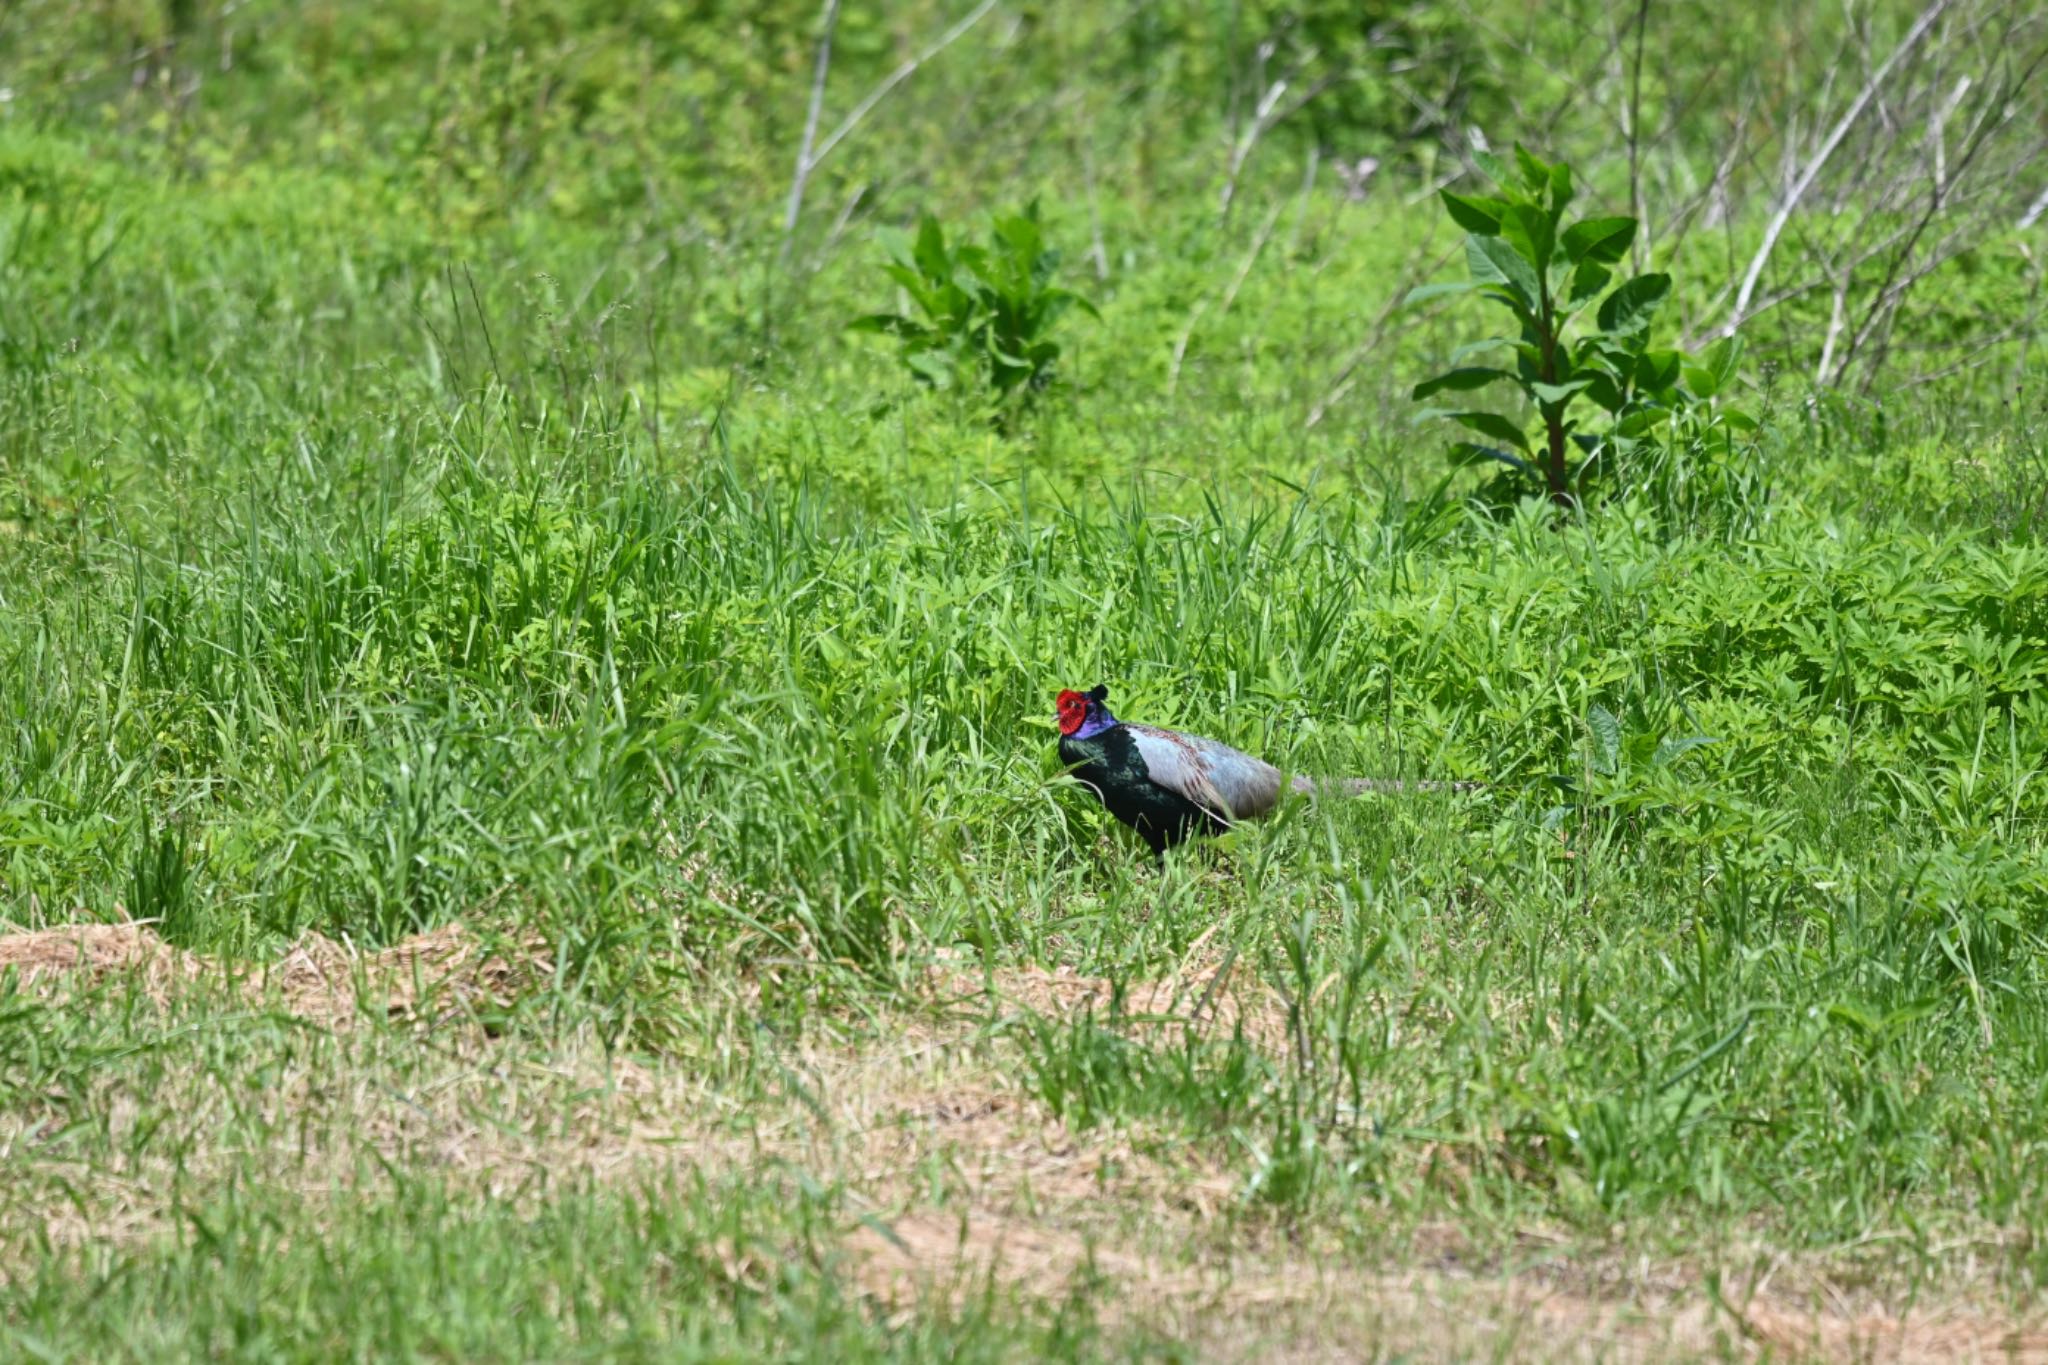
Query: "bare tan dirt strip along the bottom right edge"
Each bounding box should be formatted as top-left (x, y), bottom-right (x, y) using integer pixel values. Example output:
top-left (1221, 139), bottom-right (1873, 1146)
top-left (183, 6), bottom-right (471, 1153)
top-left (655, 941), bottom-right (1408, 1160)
top-left (842, 1209), bottom-right (2048, 1363)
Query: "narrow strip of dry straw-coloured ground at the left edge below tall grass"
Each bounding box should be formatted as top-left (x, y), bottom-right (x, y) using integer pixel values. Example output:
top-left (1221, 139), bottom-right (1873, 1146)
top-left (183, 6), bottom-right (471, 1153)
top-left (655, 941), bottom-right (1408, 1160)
top-left (0, 923), bottom-right (549, 1027)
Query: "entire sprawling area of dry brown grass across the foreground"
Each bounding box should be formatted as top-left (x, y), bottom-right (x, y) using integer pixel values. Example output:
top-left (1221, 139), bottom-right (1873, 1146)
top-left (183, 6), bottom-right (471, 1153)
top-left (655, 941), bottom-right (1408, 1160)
top-left (12, 925), bottom-right (2048, 1361)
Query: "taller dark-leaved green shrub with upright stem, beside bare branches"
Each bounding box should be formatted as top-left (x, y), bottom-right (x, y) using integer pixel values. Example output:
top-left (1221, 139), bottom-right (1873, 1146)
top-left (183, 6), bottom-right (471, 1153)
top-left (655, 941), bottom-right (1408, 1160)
top-left (1409, 145), bottom-right (1755, 508)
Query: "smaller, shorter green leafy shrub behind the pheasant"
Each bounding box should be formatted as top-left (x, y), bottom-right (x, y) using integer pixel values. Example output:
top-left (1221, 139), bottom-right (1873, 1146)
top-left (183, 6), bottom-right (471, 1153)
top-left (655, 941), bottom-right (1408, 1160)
top-left (852, 205), bottom-right (1100, 417)
